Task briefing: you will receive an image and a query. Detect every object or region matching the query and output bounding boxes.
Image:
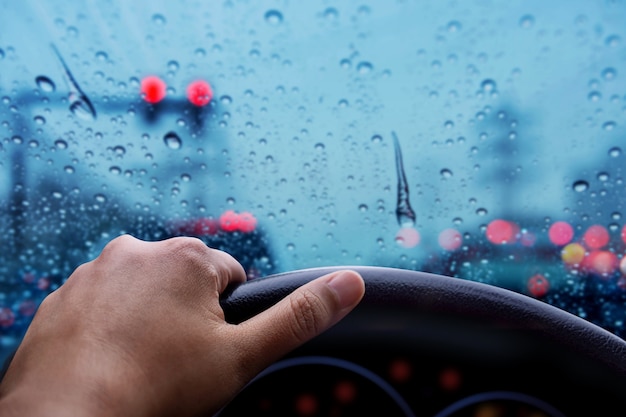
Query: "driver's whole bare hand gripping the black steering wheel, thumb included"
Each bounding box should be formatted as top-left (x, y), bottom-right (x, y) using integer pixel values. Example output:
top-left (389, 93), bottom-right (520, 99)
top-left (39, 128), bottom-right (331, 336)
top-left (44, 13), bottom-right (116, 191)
top-left (0, 235), bottom-right (365, 417)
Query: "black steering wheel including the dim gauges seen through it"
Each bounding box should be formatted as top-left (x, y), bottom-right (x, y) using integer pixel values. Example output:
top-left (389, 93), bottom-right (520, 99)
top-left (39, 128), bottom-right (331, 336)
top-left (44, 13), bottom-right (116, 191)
top-left (218, 266), bottom-right (626, 417)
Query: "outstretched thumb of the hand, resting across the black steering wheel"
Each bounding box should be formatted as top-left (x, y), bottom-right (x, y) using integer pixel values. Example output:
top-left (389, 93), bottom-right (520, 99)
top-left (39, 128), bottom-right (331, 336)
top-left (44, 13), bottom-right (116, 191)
top-left (237, 270), bottom-right (365, 372)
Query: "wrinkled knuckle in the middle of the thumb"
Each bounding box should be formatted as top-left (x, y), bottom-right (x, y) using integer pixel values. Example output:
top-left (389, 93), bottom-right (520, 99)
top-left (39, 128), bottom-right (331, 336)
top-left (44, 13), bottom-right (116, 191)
top-left (291, 290), bottom-right (327, 342)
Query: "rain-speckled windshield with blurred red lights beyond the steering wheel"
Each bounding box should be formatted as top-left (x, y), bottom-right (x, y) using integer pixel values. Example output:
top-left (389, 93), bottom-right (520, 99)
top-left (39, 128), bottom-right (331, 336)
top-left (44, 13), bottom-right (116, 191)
top-left (0, 0), bottom-right (626, 360)
